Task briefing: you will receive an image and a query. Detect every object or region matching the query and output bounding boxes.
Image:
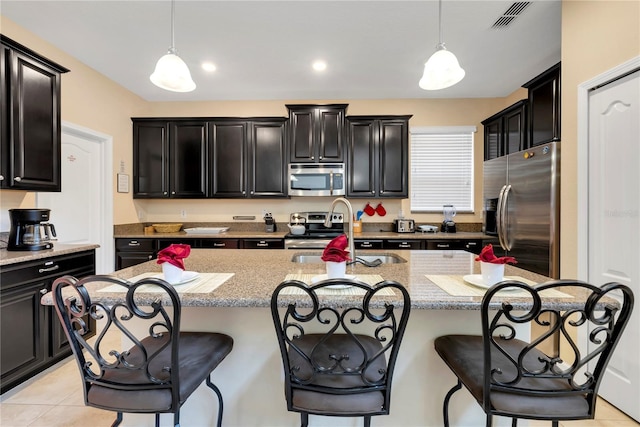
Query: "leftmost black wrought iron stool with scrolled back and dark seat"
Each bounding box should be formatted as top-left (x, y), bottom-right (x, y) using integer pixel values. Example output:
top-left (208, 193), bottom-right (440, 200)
top-left (52, 275), bottom-right (233, 426)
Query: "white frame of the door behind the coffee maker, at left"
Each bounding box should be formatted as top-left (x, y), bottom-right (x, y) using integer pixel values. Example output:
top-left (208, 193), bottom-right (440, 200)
top-left (36, 121), bottom-right (115, 274)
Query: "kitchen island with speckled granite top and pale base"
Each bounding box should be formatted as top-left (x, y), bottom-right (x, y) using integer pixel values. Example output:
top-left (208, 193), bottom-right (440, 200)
top-left (43, 249), bottom-right (579, 427)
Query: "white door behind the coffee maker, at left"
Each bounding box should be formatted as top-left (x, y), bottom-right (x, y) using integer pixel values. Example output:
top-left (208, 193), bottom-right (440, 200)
top-left (36, 124), bottom-right (114, 273)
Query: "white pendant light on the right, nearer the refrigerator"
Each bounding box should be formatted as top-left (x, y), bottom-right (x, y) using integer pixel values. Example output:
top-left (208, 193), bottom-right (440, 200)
top-left (418, 0), bottom-right (464, 90)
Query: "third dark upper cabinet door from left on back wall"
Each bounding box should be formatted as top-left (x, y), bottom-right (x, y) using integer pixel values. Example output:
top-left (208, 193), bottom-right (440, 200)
top-left (210, 121), bottom-right (248, 197)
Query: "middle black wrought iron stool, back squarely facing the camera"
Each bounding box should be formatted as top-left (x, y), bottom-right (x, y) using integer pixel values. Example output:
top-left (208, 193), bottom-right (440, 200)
top-left (271, 279), bottom-right (411, 426)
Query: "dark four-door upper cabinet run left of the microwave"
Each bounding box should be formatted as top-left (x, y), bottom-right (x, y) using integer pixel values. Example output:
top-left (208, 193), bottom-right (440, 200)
top-left (132, 117), bottom-right (287, 198)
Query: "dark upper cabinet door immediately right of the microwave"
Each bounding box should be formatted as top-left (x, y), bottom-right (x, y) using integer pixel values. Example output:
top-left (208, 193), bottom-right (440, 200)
top-left (347, 119), bottom-right (378, 197)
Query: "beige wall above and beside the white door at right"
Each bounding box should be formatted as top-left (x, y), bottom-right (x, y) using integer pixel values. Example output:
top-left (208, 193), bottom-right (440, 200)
top-left (560, 0), bottom-right (640, 278)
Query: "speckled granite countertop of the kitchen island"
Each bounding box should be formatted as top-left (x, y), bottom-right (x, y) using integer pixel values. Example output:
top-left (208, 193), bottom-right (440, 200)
top-left (43, 249), bottom-right (592, 310)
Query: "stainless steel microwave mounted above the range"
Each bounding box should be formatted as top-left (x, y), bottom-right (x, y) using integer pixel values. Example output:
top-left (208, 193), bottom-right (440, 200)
top-left (289, 163), bottom-right (346, 196)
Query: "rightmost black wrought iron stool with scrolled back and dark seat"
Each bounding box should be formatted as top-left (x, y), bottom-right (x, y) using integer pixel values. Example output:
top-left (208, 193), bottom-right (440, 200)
top-left (436, 280), bottom-right (634, 426)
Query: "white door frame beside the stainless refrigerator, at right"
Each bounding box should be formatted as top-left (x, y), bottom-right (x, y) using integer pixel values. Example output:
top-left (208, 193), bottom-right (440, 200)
top-left (576, 56), bottom-right (640, 280)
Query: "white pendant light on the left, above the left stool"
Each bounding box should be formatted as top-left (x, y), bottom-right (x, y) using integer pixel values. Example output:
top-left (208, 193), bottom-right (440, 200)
top-left (149, 0), bottom-right (196, 92)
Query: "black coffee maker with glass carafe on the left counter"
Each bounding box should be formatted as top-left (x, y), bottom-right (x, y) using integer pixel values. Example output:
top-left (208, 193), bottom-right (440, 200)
top-left (7, 209), bottom-right (56, 251)
